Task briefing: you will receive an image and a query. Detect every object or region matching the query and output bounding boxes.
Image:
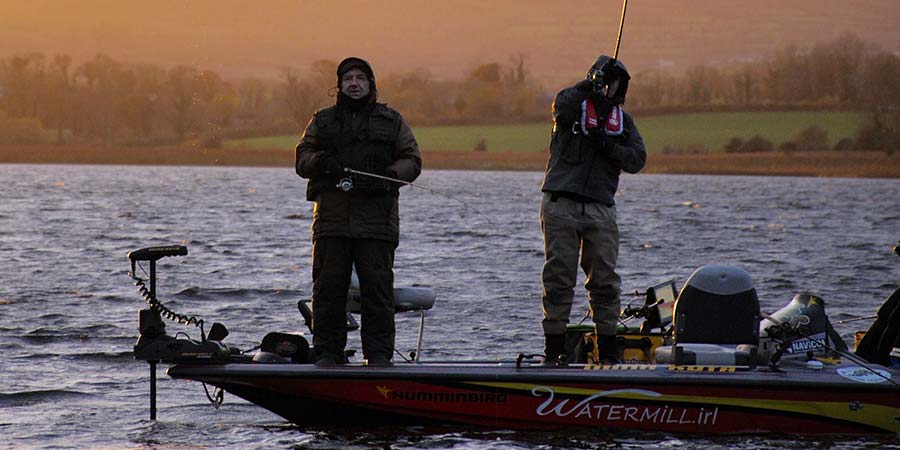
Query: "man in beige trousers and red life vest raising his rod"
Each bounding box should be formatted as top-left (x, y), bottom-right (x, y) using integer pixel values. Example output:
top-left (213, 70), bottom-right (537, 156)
top-left (541, 56), bottom-right (646, 365)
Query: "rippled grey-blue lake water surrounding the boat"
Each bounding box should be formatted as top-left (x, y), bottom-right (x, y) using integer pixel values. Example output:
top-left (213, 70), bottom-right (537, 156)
top-left (0, 165), bottom-right (900, 449)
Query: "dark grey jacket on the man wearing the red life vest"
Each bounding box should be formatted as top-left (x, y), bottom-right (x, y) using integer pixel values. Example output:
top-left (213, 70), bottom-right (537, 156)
top-left (541, 60), bottom-right (647, 206)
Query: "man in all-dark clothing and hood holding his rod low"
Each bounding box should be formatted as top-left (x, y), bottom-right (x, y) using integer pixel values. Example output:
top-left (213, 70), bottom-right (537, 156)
top-left (296, 57), bottom-right (422, 366)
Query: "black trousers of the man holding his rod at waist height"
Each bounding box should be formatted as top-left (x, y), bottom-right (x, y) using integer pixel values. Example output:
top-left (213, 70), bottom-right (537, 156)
top-left (312, 237), bottom-right (397, 360)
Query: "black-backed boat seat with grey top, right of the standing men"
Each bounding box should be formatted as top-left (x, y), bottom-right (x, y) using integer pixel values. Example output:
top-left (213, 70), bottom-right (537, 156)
top-left (654, 265), bottom-right (760, 366)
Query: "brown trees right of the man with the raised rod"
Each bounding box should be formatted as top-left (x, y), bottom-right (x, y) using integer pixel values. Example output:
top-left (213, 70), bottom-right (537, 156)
top-left (629, 35), bottom-right (900, 110)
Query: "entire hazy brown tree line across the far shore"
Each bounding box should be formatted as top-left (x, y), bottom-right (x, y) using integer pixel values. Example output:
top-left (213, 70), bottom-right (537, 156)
top-left (0, 36), bottom-right (900, 146)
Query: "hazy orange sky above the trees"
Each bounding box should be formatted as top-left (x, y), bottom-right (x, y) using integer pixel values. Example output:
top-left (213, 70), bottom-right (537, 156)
top-left (0, 0), bottom-right (900, 83)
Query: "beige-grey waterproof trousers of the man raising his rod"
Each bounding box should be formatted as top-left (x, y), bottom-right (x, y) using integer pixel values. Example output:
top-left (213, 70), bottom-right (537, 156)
top-left (541, 193), bottom-right (621, 336)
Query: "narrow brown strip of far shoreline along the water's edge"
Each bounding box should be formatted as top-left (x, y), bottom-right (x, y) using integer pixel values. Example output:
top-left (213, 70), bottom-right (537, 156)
top-left (0, 145), bottom-right (900, 178)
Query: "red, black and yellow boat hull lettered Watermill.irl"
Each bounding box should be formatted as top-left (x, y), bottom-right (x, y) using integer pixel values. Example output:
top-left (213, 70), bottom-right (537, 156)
top-left (169, 363), bottom-right (900, 434)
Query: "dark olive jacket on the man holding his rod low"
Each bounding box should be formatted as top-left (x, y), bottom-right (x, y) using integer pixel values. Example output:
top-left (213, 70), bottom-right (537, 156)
top-left (295, 102), bottom-right (422, 243)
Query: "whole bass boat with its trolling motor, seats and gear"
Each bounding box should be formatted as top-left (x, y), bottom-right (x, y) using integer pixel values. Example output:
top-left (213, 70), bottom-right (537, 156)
top-left (129, 246), bottom-right (900, 434)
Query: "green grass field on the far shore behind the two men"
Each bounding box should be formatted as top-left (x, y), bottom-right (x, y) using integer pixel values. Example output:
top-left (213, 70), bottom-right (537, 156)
top-left (226, 111), bottom-right (865, 153)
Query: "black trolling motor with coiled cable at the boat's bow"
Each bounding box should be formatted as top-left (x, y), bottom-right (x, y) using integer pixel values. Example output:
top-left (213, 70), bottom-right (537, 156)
top-left (128, 245), bottom-right (231, 420)
